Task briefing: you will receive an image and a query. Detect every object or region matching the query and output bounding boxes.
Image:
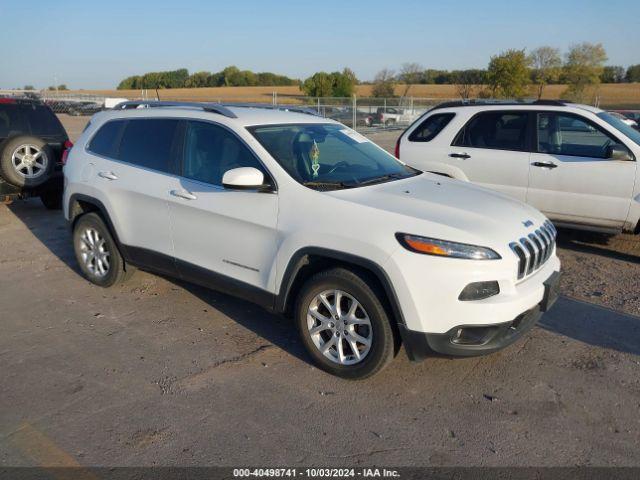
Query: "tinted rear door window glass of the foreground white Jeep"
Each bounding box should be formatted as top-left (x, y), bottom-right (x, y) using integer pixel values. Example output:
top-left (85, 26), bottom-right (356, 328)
top-left (117, 118), bottom-right (179, 173)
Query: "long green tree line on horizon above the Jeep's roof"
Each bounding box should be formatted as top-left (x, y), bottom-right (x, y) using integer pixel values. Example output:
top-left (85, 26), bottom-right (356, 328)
top-left (117, 65), bottom-right (299, 90)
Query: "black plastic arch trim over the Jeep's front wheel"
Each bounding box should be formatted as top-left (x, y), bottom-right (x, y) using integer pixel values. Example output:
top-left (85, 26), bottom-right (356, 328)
top-left (275, 247), bottom-right (405, 324)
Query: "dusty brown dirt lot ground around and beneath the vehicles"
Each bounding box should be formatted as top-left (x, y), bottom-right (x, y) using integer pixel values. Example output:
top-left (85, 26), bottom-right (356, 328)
top-left (0, 114), bottom-right (640, 466)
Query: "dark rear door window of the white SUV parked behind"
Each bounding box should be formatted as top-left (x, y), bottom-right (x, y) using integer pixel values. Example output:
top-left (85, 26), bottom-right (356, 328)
top-left (453, 112), bottom-right (528, 151)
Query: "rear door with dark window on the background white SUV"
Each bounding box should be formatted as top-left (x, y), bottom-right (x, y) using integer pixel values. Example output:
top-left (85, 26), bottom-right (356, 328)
top-left (445, 110), bottom-right (530, 201)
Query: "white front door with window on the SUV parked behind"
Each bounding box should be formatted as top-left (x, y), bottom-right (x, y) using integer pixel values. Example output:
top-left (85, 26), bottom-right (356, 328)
top-left (527, 111), bottom-right (637, 228)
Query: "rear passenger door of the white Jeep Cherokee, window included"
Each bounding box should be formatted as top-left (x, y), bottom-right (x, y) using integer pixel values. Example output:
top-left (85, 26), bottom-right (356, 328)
top-left (87, 118), bottom-right (182, 274)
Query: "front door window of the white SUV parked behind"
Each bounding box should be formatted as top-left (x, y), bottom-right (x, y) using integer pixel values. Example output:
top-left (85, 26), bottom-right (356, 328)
top-left (537, 112), bottom-right (626, 159)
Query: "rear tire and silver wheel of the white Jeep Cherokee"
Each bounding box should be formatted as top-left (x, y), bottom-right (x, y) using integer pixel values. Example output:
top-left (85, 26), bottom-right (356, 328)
top-left (73, 213), bottom-right (133, 287)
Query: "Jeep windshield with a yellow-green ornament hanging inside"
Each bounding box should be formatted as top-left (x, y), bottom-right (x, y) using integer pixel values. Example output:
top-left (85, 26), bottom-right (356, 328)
top-left (249, 123), bottom-right (420, 189)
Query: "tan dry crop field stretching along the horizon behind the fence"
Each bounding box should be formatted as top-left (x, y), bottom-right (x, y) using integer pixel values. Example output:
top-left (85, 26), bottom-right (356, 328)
top-left (70, 83), bottom-right (640, 108)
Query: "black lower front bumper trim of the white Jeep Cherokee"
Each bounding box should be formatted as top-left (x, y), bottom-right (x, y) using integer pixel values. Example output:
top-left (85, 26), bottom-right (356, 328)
top-left (399, 272), bottom-right (560, 361)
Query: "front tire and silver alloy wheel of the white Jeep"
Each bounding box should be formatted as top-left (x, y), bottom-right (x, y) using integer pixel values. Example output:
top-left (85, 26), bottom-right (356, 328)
top-left (295, 268), bottom-right (396, 380)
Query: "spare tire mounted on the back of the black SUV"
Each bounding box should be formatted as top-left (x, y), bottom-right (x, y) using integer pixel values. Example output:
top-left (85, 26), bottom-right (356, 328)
top-left (0, 136), bottom-right (56, 188)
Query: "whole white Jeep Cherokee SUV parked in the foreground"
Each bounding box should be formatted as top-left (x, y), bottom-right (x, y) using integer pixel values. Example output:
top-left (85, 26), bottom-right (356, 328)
top-left (64, 102), bottom-right (560, 378)
